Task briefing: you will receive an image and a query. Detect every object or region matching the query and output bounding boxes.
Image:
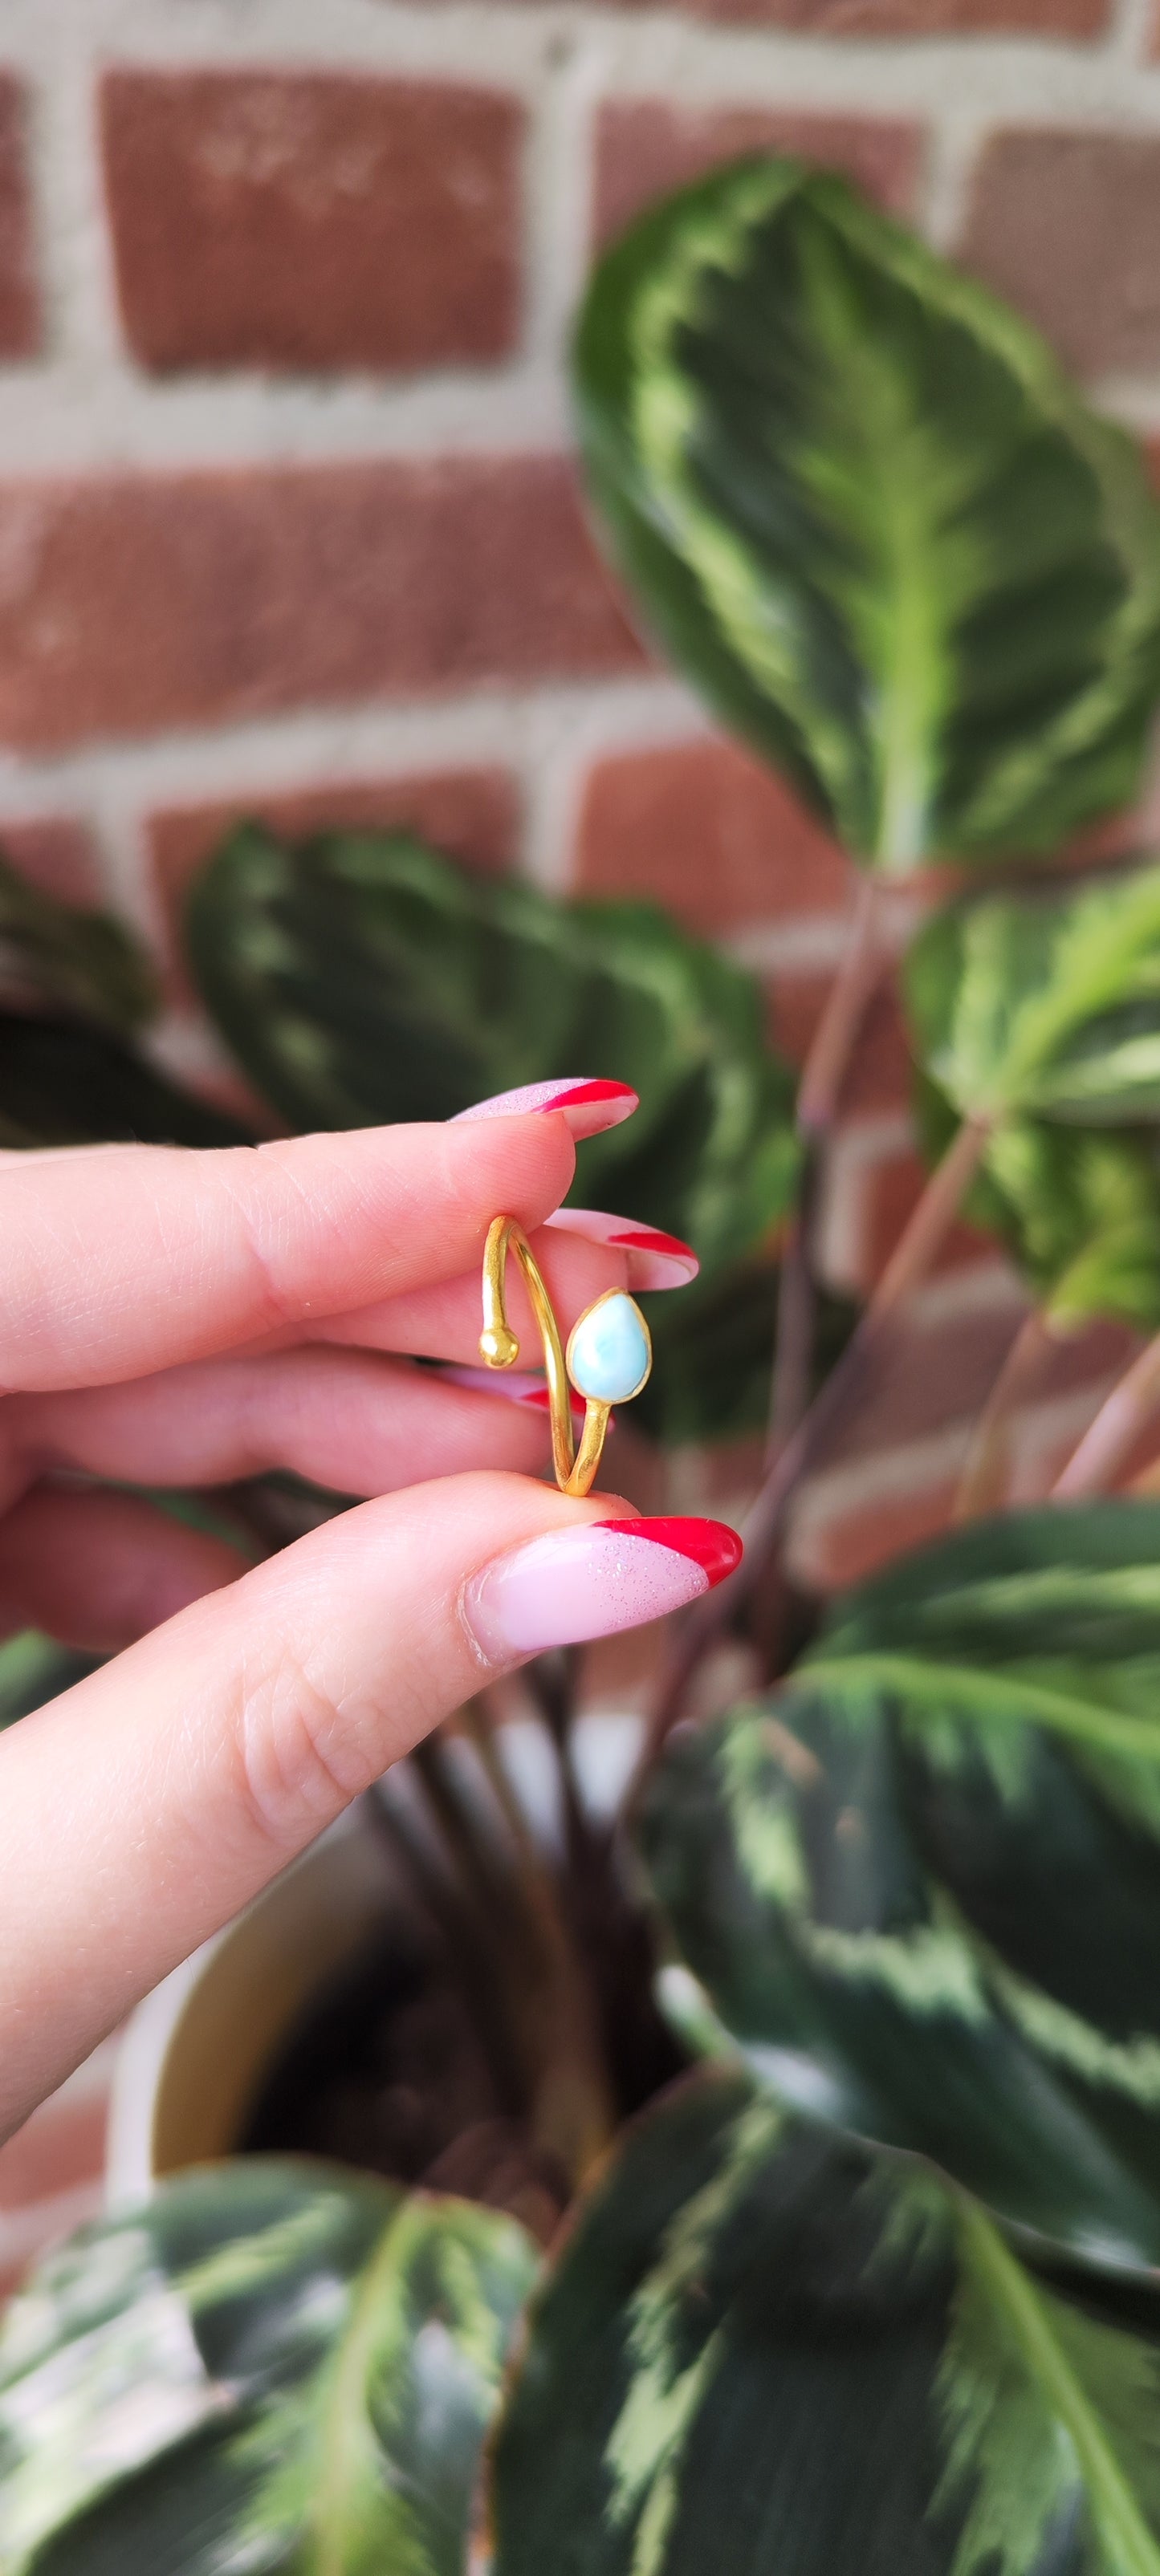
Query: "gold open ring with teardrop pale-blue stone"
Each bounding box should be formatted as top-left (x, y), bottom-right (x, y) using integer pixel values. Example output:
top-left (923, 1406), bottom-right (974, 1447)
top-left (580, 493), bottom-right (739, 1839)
top-left (479, 1216), bottom-right (652, 1494)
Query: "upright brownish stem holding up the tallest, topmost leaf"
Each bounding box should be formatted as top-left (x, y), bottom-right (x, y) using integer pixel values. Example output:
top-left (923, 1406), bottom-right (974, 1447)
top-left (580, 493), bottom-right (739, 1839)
top-left (766, 876), bottom-right (884, 1465)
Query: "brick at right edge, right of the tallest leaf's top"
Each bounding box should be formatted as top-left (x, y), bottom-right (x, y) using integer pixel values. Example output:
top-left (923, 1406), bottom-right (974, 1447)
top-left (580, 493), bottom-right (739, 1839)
top-left (962, 126), bottom-right (1160, 376)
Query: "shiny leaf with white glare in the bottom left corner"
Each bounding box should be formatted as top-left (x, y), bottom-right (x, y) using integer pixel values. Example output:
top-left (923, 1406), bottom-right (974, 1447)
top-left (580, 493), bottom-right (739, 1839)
top-left (0, 2159), bottom-right (536, 2576)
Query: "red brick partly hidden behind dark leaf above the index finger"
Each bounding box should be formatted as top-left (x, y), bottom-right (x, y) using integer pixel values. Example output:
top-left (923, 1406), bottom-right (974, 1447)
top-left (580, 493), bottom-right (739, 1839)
top-left (149, 770), bottom-right (518, 1002)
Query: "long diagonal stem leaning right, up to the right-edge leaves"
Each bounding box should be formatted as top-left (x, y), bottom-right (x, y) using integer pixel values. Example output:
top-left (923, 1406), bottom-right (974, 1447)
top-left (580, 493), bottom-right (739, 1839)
top-left (645, 1118), bottom-right (990, 1762)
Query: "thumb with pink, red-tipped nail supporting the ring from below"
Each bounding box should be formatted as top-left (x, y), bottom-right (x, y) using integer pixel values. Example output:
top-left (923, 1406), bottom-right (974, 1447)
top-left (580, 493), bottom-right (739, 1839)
top-left (0, 1476), bottom-right (740, 2135)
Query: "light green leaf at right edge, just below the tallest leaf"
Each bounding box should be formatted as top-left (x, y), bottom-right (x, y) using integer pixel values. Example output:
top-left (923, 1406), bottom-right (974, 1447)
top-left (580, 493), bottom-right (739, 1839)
top-left (905, 866), bottom-right (1160, 1126)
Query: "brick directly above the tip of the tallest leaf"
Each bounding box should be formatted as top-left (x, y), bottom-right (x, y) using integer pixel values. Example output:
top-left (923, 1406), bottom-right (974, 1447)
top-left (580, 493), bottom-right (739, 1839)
top-left (593, 98), bottom-right (923, 242)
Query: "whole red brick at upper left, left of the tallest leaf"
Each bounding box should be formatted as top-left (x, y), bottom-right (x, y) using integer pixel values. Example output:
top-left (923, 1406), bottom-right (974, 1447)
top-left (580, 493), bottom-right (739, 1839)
top-left (100, 70), bottom-right (523, 368)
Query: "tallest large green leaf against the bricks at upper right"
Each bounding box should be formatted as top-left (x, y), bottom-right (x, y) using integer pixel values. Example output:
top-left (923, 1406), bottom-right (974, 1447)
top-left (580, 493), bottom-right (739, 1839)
top-left (575, 157), bottom-right (1160, 871)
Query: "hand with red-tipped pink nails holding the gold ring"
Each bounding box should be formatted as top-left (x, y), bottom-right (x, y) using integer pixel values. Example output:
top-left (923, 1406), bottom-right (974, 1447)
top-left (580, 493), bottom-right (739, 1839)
top-left (0, 1084), bottom-right (740, 2135)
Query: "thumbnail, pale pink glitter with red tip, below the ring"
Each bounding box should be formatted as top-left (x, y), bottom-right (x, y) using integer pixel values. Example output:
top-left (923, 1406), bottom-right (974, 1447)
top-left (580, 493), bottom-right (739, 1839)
top-left (464, 1520), bottom-right (743, 1664)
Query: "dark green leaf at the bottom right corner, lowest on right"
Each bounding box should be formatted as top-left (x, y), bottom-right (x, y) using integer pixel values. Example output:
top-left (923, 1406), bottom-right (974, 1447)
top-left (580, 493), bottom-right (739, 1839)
top-left (495, 2076), bottom-right (1160, 2576)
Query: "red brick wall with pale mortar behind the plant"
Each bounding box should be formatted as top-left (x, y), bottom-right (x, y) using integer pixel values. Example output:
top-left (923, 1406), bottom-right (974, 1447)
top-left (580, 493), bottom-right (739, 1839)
top-left (0, 0), bottom-right (1160, 2287)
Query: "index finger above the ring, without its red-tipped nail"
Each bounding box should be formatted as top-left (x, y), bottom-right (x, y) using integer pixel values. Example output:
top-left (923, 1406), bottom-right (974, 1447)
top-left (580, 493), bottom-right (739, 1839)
top-left (0, 1115), bottom-right (575, 1391)
